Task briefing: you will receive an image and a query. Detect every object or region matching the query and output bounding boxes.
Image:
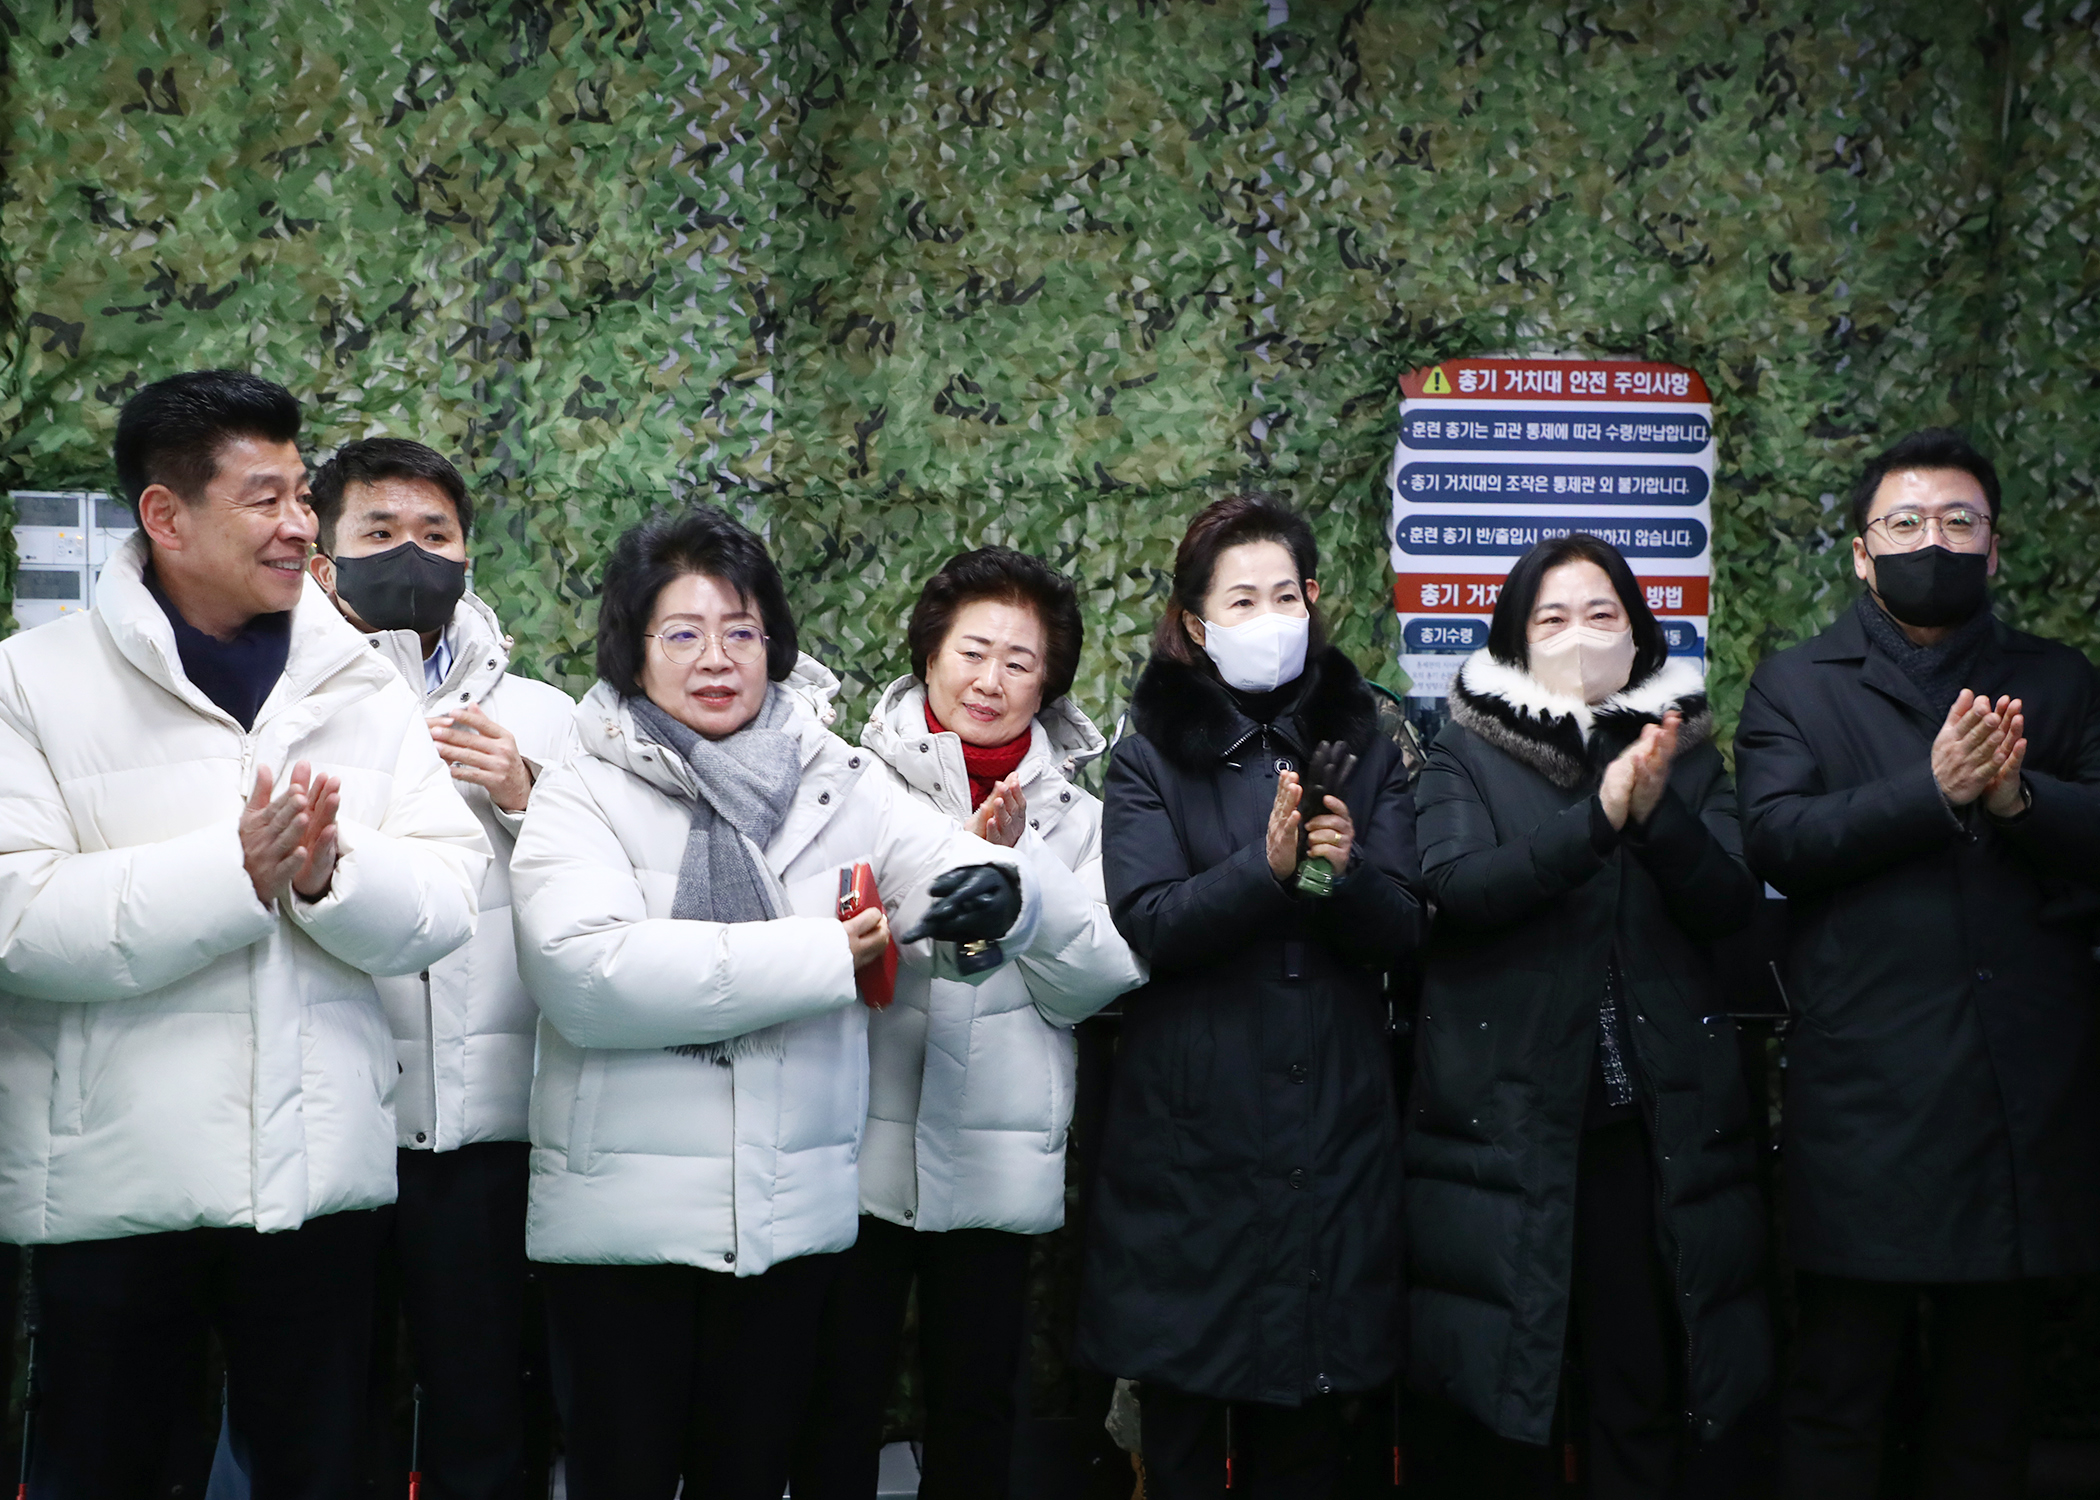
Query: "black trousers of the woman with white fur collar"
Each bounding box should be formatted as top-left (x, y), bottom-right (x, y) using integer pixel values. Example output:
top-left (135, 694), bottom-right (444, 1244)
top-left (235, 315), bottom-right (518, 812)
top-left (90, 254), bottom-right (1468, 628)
top-left (1569, 1120), bottom-right (1688, 1500)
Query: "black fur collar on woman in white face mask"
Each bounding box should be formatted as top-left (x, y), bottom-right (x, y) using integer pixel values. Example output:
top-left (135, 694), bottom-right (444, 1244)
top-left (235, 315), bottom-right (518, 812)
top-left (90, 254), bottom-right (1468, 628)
top-left (1130, 645), bottom-right (1378, 771)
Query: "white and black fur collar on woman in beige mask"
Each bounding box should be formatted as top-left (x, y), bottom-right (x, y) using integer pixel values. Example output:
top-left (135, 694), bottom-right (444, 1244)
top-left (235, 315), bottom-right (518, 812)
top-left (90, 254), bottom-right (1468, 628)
top-left (1451, 647), bottom-right (1714, 786)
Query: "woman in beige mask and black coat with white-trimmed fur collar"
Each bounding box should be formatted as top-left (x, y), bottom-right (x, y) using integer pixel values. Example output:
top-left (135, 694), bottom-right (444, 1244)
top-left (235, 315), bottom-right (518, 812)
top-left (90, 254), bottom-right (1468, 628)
top-left (1407, 536), bottom-right (1770, 1498)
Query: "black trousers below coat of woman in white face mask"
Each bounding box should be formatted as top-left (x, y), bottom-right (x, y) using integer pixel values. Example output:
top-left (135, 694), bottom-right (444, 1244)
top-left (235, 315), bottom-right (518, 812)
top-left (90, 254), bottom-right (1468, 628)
top-left (1138, 1380), bottom-right (1342, 1500)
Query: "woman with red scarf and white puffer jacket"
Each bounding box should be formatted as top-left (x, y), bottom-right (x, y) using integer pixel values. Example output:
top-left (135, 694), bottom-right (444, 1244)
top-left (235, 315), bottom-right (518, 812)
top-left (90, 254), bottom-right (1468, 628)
top-left (796, 546), bottom-right (1145, 1500)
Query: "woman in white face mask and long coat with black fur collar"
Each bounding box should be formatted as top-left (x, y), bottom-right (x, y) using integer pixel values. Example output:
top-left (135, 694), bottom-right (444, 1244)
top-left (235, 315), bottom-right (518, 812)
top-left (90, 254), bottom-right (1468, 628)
top-left (1077, 496), bottom-right (1424, 1500)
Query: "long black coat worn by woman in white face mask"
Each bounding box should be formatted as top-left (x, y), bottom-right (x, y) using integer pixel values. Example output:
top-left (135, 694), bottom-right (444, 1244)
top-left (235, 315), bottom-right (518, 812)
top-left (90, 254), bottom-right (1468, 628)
top-left (1077, 649), bottom-right (1424, 1405)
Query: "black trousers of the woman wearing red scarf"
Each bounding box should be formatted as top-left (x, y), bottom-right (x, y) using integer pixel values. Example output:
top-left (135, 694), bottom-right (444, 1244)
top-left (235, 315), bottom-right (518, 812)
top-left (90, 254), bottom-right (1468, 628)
top-left (794, 1214), bottom-right (1029, 1500)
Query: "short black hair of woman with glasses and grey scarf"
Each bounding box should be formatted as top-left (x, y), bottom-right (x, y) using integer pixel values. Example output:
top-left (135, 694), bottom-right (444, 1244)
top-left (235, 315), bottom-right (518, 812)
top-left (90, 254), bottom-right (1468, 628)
top-left (599, 504), bottom-right (800, 697)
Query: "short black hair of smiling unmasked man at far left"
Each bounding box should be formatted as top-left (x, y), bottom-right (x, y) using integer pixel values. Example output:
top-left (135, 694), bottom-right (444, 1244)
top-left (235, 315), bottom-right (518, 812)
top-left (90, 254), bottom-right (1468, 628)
top-left (116, 370), bottom-right (298, 511)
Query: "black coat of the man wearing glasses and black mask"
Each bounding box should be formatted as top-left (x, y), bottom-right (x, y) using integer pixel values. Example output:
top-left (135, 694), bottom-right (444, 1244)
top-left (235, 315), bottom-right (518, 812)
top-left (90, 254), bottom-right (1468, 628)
top-left (1735, 611), bottom-right (2100, 1282)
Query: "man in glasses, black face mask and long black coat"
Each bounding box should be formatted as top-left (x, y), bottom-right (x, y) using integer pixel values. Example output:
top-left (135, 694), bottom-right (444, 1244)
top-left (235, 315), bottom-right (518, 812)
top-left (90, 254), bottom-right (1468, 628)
top-left (1735, 429), bottom-right (2100, 1500)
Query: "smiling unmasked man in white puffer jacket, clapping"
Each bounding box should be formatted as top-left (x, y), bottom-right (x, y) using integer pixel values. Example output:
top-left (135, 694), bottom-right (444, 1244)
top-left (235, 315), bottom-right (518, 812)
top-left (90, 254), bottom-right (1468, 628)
top-left (0, 372), bottom-right (489, 1500)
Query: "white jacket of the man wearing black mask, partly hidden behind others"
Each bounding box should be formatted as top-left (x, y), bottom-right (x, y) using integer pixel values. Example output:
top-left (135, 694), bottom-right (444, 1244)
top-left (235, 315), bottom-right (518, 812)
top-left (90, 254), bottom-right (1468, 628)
top-left (365, 595), bottom-right (575, 1151)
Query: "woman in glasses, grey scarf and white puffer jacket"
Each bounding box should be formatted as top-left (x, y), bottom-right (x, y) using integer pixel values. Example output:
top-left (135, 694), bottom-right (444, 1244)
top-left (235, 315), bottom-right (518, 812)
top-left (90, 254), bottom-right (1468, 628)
top-left (510, 506), bottom-right (1058, 1500)
